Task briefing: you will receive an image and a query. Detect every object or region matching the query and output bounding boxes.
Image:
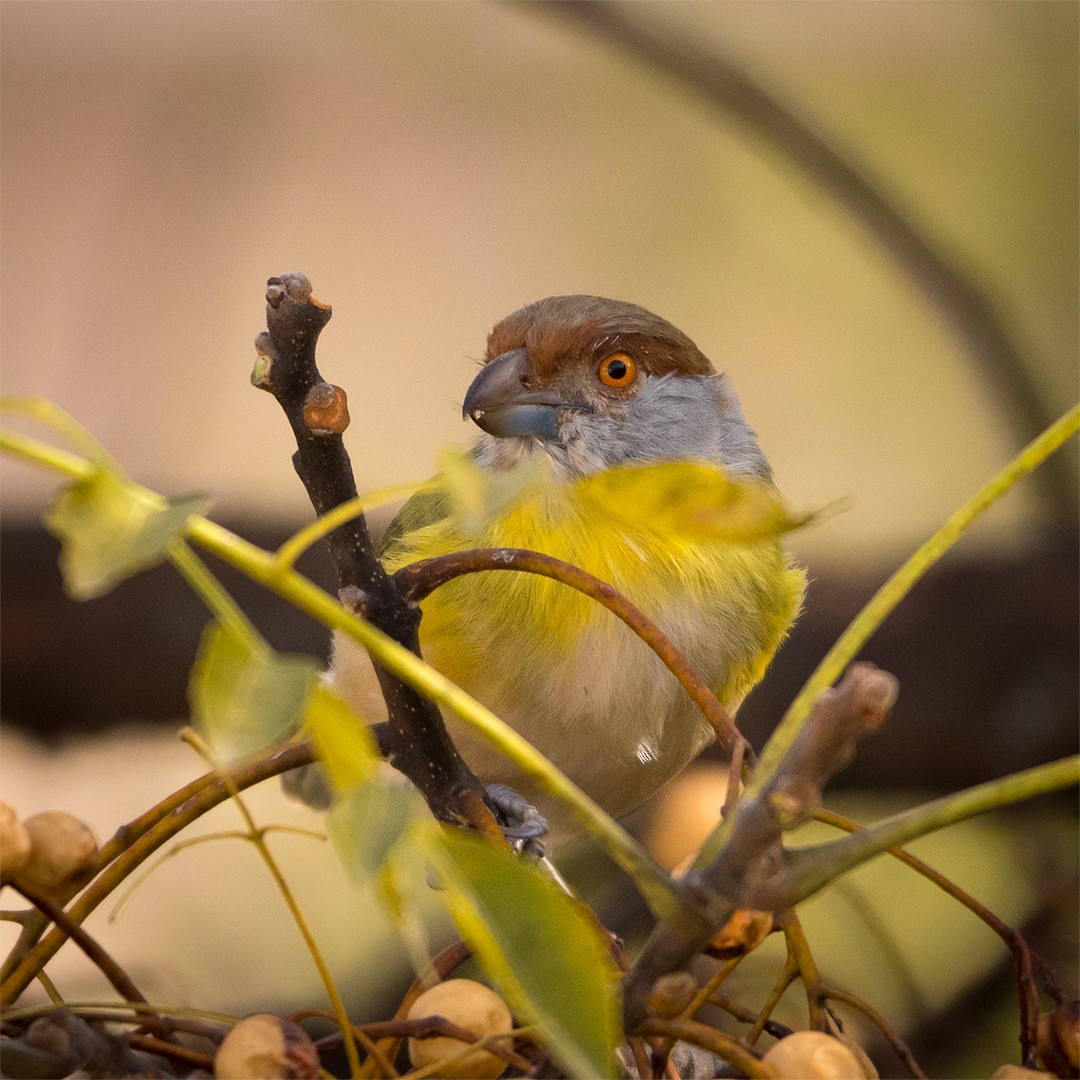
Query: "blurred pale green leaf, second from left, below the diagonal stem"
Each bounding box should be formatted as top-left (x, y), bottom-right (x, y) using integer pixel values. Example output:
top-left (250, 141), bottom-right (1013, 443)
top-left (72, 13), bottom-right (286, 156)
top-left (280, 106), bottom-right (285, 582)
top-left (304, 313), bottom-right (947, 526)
top-left (188, 622), bottom-right (319, 760)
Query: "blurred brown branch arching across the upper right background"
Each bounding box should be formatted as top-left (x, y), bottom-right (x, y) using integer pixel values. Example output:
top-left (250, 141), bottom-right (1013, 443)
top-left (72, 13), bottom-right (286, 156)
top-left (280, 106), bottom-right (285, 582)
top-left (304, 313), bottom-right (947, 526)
top-left (529, 0), bottom-right (1080, 529)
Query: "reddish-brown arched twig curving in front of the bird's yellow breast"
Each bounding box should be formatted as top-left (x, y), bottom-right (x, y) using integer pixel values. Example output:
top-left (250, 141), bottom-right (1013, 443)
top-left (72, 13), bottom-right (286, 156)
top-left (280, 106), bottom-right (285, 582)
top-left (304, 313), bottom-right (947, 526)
top-left (394, 548), bottom-right (754, 764)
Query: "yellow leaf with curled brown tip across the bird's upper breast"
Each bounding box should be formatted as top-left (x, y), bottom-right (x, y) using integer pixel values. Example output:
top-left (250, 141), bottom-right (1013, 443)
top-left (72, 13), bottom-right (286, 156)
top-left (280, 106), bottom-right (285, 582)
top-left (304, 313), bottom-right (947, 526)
top-left (575, 461), bottom-right (813, 543)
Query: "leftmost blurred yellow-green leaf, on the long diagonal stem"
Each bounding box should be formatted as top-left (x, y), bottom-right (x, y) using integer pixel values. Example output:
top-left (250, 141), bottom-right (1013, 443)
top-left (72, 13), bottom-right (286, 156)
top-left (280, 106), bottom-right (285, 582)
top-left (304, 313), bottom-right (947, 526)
top-left (45, 470), bottom-right (208, 600)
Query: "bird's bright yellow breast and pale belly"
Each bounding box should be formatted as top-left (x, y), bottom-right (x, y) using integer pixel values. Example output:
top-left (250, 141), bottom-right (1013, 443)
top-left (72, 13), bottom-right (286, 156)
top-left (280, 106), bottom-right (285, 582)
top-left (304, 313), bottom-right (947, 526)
top-left (388, 468), bottom-right (805, 812)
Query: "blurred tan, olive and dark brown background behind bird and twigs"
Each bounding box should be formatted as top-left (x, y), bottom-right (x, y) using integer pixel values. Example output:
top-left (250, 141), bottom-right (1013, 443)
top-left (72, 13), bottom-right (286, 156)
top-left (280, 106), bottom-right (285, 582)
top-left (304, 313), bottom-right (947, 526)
top-left (0, 0), bottom-right (1080, 1076)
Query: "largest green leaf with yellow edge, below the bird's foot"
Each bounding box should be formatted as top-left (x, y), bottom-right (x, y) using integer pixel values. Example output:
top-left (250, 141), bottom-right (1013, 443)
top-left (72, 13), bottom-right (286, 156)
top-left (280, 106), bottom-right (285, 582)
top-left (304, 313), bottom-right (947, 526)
top-left (420, 825), bottom-right (622, 1077)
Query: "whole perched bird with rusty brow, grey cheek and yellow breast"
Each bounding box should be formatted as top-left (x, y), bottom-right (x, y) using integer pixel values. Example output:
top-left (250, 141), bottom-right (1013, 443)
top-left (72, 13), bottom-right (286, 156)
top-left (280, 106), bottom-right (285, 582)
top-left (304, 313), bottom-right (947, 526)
top-left (319, 295), bottom-right (806, 845)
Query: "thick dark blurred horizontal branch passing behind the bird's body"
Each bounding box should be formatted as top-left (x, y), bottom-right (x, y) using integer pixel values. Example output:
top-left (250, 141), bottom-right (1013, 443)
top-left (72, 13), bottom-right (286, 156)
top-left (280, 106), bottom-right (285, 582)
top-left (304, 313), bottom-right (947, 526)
top-left (0, 521), bottom-right (1080, 791)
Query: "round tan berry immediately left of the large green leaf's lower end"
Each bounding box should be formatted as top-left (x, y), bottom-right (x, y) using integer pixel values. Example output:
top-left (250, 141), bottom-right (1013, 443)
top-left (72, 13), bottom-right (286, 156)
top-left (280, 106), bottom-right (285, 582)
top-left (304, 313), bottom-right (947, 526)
top-left (408, 978), bottom-right (514, 1080)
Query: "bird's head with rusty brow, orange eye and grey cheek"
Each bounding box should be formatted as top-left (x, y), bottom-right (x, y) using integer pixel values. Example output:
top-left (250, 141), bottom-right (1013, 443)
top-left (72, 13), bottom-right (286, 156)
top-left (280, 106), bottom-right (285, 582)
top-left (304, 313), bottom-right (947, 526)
top-left (462, 296), bottom-right (769, 478)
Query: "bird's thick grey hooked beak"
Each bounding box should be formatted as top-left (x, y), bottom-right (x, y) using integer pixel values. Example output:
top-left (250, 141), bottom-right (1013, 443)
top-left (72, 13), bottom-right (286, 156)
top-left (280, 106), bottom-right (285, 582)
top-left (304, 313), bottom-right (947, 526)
top-left (461, 349), bottom-right (567, 440)
